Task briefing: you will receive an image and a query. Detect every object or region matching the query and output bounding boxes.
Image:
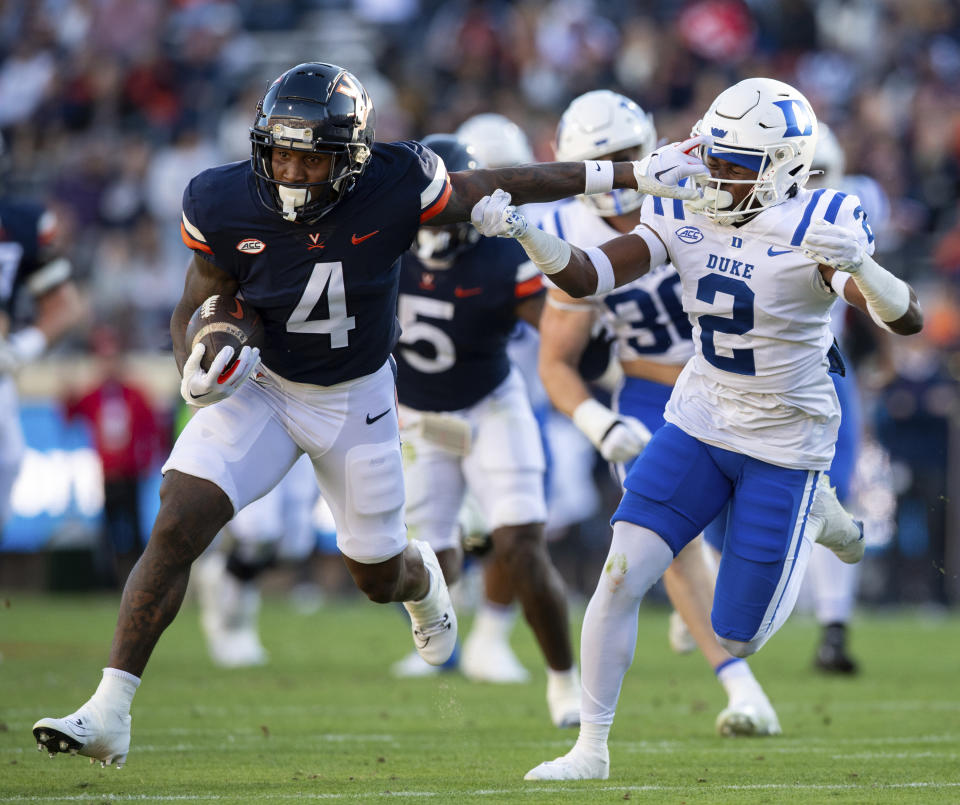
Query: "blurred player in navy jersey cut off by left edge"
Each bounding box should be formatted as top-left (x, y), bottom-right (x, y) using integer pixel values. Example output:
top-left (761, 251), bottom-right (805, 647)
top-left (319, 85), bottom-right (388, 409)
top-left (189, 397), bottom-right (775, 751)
top-left (0, 139), bottom-right (85, 539)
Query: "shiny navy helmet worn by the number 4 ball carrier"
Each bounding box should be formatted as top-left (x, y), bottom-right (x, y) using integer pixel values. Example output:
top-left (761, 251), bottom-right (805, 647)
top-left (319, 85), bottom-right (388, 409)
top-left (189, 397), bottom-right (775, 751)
top-left (250, 62), bottom-right (376, 224)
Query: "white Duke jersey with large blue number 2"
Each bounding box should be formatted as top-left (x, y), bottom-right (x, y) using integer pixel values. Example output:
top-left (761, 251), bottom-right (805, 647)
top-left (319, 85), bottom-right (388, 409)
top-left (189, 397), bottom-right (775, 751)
top-left (641, 189), bottom-right (873, 470)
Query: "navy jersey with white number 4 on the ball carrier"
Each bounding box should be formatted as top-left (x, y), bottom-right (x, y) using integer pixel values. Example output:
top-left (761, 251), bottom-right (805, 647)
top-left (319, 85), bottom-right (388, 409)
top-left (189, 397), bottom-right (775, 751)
top-left (181, 142), bottom-right (450, 386)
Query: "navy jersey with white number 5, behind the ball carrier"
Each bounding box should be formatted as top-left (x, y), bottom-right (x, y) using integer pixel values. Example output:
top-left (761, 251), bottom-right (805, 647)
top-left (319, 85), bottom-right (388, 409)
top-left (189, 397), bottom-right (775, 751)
top-left (393, 232), bottom-right (544, 411)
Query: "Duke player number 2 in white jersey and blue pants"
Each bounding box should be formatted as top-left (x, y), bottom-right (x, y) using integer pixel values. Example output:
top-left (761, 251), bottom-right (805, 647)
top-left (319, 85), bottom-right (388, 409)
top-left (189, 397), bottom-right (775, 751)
top-left (472, 78), bottom-right (923, 780)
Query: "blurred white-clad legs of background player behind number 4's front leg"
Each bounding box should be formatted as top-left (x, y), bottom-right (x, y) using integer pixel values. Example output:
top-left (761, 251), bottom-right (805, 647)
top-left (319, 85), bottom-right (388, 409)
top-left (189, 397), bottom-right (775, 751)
top-left (194, 455), bottom-right (320, 668)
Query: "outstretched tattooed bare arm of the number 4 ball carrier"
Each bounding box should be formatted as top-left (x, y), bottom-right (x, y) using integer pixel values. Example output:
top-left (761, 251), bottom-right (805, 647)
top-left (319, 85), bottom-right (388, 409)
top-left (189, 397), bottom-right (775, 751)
top-left (430, 162), bottom-right (637, 226)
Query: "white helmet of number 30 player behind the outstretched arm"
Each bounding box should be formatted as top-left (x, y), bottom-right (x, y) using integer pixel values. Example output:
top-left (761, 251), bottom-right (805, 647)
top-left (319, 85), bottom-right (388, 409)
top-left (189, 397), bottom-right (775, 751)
top-left (556, 89), bottom-right (657, 218)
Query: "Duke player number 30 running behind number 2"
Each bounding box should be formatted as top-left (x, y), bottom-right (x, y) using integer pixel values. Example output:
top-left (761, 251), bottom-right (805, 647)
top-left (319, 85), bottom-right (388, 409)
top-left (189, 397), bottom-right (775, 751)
top-left (540, 90), bottom-right (780, 736)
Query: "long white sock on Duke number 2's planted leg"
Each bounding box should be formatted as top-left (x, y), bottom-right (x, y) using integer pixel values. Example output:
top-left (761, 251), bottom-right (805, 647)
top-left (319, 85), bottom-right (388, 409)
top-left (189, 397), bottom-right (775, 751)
top-left (580, 520), bottom-right (673, 727)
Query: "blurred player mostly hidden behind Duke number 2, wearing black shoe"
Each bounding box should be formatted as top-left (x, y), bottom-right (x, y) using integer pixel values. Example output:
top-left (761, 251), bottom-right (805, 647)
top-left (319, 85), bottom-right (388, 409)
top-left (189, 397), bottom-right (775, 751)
top-left (807, 123), bottom-right (890, 674)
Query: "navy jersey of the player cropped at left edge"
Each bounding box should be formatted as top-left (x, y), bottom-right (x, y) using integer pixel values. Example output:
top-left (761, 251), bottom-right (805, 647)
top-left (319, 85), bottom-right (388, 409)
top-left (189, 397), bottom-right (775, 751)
top-left (0, 199), bottom-right (61, 317)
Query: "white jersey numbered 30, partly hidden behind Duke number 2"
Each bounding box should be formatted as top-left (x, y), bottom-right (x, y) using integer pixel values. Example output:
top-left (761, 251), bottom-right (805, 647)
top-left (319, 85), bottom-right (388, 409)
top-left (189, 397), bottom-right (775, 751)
top-left (539, 199), bottom-right (693, 365)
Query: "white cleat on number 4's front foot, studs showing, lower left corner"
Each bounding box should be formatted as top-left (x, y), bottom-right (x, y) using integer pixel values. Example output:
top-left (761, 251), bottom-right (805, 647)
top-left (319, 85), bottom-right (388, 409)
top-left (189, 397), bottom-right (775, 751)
top-left (33, 701), bottom-right (131, 769)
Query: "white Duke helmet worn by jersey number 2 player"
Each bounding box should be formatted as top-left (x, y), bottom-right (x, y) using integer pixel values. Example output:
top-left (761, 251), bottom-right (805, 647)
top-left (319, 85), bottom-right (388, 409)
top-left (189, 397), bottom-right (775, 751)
top-left (692, 78), bottom-right (818, 223)
